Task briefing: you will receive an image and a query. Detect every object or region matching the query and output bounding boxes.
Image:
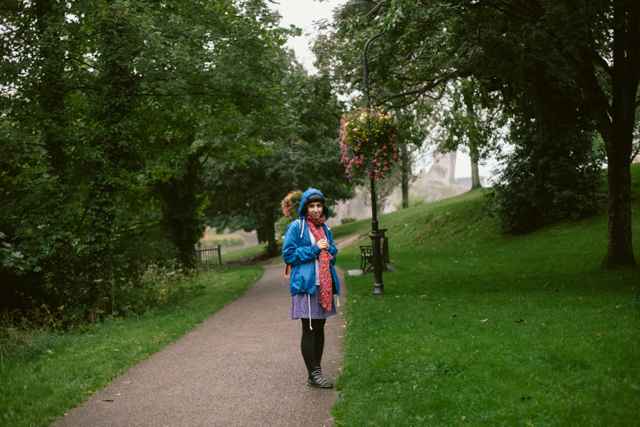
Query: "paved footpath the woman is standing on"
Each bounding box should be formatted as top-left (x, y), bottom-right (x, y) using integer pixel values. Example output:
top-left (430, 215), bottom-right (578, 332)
top-left (55, 264), bottom-right (344, 427)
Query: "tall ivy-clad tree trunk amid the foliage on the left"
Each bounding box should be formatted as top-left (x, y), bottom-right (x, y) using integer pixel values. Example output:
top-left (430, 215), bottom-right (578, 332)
top-left (87, 4), bottom-right (140, 304)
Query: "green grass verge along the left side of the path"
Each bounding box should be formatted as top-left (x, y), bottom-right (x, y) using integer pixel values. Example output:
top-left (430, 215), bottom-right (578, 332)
top-left (0, 267), bottom-right (263, 427)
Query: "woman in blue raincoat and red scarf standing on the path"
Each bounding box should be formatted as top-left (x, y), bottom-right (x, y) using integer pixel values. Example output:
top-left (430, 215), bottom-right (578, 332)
top-left (282, 188), bottom-right (340, 388)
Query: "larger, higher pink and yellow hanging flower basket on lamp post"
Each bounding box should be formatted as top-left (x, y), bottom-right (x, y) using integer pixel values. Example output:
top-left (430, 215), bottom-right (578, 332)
top-left (340, 107), bottom-right (400, 185)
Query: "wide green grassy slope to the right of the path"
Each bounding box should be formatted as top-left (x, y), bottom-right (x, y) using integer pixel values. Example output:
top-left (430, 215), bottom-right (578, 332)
top-left (333, 165), bottom-right (640, 427)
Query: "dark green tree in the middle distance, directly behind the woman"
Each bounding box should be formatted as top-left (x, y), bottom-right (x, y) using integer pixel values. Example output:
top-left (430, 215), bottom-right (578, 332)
top-left (204, 70), bottom-right (353, 257)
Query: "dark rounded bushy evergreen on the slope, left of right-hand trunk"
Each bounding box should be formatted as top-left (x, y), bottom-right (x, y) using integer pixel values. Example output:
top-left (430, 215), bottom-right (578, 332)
top-left (488, 69), bottom-right (604, 233)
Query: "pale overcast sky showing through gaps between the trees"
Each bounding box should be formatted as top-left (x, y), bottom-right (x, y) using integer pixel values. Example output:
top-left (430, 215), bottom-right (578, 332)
top-left (274, 0), bottom-right (494, 178)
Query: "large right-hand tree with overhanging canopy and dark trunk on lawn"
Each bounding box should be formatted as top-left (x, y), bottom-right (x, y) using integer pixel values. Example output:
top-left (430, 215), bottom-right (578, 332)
top-left (315, 0), bottom-right (640, 268)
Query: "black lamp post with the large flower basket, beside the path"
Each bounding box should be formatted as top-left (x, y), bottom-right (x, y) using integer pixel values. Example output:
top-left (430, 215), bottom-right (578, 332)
top-left (346, 0), bottom-right (386, 295)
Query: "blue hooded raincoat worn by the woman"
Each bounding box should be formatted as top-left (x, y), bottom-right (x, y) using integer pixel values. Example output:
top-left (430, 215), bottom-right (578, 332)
top-left (282, 188), bottom-right (340, 295)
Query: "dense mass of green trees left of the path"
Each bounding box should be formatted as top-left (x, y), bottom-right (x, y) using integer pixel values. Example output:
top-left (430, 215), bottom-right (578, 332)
top-left (0, 0), bottom-right (291, 323)
